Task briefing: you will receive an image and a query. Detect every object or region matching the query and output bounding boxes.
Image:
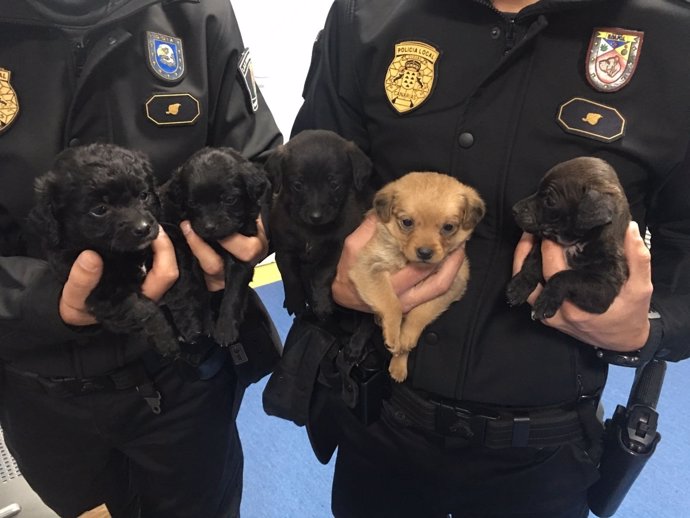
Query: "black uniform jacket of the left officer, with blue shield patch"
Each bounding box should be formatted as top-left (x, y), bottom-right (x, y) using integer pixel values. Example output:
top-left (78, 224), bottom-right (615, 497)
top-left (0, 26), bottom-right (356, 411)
top-left (0, 0), bottom-right (281, 376)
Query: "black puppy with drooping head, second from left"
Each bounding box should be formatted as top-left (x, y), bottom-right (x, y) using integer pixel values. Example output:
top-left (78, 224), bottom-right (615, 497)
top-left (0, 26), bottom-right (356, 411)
top-left (161, 147), bottom-right (269, 346)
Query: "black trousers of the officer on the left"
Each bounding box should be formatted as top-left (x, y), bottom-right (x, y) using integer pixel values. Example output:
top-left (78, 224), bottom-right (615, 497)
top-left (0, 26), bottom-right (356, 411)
top-left (0, 367), bottom-right (243, 518)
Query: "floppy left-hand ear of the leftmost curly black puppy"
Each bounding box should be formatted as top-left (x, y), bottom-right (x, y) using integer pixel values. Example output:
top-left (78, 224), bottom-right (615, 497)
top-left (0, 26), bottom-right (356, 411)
top-left (28, 172), bottom-right (62, 248)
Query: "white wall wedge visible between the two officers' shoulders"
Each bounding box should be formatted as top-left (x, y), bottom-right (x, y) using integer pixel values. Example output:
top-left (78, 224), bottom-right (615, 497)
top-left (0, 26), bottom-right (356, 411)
top-left (231, 0), bottom-right (331, 140)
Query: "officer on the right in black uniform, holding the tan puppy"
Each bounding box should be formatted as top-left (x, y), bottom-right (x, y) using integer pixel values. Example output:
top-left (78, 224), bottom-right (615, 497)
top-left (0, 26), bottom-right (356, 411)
top-left (293, 0), bottom-right (690, 518)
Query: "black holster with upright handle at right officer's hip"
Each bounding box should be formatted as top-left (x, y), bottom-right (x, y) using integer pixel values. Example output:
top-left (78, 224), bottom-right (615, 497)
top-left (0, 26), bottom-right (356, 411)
top-left (588, 360), bottom-right (666, 518)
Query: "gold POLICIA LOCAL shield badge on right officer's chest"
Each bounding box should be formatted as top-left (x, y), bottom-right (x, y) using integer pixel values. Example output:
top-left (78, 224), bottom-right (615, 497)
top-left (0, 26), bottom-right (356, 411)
top-left (384, 41), bottom-right (441, 113)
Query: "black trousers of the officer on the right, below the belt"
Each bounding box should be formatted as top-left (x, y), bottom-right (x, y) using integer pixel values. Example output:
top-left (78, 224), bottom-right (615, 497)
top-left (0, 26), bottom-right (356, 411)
top-left (319, 395), bottom-right (598, 518)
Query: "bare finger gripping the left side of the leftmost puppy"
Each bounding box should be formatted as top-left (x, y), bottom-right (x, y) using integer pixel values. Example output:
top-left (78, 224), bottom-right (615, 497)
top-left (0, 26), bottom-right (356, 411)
top-left (58, 250), bottom-right (103, 326)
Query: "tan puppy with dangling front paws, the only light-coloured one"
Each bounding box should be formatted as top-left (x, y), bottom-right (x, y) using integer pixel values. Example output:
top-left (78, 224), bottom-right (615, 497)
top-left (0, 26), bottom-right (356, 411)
top-left (349, 172), bottom-right (486, 382)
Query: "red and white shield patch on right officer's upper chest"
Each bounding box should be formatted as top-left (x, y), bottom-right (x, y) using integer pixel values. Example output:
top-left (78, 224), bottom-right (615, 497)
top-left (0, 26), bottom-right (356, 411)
top-left (587, 28), bottom-right (644, 92)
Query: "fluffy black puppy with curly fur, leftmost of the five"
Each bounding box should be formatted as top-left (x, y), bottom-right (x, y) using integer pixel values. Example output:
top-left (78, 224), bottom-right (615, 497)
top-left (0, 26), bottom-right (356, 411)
top-left (29, 144), bottom-right (179, 356)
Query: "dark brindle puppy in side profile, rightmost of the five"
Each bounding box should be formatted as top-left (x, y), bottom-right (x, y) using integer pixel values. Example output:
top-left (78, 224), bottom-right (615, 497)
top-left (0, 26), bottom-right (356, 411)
top-left (507, 157), bottom-right (630, 320)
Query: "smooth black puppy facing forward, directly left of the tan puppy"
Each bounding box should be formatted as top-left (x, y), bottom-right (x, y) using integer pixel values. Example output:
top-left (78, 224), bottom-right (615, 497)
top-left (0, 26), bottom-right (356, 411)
top-left (266, 130), bottom-right (373, 319)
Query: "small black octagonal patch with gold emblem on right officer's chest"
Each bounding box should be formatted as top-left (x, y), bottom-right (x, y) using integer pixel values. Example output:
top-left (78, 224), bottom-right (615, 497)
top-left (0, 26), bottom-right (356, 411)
top-left (558, 97), bottom-right (625, 142)
